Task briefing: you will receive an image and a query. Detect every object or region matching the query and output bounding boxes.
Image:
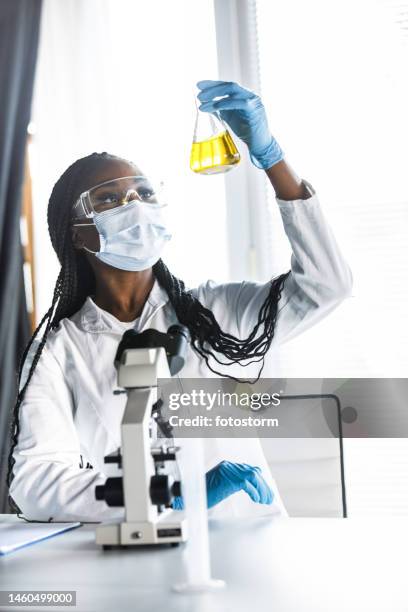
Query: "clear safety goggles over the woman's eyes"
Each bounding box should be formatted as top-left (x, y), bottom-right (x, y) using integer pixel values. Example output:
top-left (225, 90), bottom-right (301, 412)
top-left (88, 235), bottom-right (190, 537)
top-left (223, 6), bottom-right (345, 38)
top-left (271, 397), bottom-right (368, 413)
top-left (72, 176), bottom-right (165, 219)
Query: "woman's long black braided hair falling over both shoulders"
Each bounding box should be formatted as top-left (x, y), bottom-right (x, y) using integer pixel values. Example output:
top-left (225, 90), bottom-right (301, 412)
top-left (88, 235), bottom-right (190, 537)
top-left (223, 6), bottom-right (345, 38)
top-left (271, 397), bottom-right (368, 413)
top-left (7, 152), bottom-right (289, 513)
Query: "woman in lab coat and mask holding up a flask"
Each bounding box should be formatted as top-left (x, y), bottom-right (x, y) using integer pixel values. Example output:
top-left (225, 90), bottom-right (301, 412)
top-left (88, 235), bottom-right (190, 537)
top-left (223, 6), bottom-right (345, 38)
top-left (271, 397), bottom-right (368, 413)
top-left (8, 81), bottom-right (351, 522)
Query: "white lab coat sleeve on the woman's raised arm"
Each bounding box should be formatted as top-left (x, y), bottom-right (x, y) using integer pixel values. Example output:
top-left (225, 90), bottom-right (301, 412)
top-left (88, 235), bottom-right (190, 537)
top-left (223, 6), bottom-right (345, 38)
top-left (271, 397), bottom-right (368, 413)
top-left (203, 195), bottom-right (352, 343)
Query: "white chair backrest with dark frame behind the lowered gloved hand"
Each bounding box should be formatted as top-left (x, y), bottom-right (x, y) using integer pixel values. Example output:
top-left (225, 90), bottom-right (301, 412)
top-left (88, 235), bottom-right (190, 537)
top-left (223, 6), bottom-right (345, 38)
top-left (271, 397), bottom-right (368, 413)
top-left (261, 438), bottom-right (343, 517)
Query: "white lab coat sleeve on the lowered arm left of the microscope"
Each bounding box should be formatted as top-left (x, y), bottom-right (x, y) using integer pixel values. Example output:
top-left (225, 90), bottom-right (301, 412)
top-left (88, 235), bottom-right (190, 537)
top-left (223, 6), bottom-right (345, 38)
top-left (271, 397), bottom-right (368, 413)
top-left (10, 345), bottom-right (124, 522)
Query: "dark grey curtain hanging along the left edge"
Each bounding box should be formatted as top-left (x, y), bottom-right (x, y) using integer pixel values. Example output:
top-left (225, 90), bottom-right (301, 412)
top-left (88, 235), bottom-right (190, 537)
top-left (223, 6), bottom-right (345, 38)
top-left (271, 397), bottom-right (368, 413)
top-left (0, 0), bottom-right (42, 513)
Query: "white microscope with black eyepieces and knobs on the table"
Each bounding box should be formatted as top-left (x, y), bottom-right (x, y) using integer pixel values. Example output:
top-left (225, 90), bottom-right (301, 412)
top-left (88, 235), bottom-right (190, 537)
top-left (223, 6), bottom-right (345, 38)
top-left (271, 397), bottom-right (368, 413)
top-left (95, 325), bottom-right (190, 549)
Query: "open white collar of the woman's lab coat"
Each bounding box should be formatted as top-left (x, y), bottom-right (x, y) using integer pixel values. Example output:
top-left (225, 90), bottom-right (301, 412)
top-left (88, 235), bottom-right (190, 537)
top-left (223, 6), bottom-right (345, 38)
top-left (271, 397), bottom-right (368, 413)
top-left (74, 279), bottom-right (169, 334)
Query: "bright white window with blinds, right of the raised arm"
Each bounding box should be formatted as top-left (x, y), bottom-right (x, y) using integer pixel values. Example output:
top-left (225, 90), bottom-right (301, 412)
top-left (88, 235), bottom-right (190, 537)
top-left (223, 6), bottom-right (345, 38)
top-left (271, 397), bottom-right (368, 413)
top-left (257, 0), bottom-right (408, 513)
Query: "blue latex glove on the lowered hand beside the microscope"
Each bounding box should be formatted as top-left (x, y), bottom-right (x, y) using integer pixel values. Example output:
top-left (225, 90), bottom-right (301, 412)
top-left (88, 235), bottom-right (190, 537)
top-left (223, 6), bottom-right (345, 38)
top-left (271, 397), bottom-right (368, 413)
top-left (172, 461), bottom-right (273, 510)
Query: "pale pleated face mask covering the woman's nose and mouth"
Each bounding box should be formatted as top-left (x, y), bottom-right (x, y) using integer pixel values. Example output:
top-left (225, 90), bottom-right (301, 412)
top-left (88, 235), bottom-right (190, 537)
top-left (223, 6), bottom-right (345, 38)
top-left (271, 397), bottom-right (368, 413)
top-left (87, 200), bottom-right (172, 272)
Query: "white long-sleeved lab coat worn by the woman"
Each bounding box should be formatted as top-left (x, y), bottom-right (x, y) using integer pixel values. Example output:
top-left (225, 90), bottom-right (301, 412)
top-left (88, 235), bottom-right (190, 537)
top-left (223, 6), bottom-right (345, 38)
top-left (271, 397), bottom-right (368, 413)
top-left (10, 195), bottom-right (352, 522)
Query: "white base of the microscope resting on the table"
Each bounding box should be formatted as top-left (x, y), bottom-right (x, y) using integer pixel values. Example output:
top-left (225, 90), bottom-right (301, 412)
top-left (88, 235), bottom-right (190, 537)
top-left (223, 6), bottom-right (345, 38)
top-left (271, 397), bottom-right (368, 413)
top-left (96, 510), bottom-right (187, 546)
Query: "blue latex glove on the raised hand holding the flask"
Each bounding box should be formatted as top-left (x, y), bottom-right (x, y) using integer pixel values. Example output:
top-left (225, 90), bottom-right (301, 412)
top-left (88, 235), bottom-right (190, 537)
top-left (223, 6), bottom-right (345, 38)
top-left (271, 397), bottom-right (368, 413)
top-left (197, 81), bottom-right (283, 170)
